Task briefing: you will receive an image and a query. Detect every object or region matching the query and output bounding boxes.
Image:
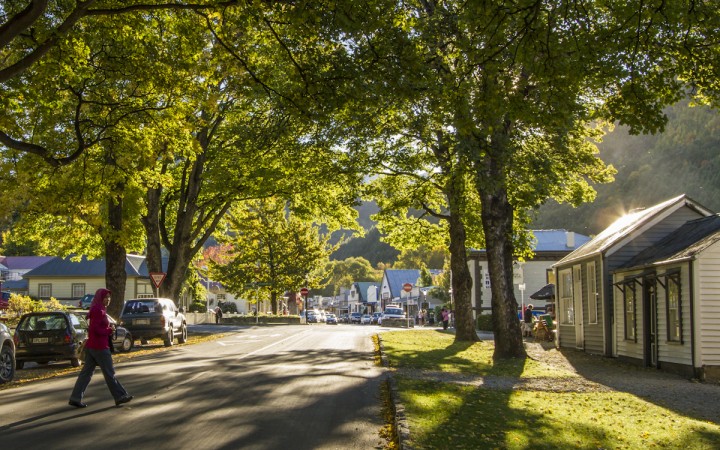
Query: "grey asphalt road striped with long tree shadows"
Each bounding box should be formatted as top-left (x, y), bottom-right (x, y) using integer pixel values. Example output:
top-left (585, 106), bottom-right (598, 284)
top-left (0, 324), bottom-right (385, 450)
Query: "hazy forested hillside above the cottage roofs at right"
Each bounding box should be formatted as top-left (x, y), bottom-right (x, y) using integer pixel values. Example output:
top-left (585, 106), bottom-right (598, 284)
top-left (533, 104), bottom-right (720, 235)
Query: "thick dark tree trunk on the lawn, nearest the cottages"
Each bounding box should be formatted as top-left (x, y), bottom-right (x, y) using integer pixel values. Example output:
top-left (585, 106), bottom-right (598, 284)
top-left (480, 189), bottom-right (526, 360)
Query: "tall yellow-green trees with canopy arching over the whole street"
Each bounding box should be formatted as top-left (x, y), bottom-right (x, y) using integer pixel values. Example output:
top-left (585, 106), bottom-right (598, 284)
top-left (0, 0), bottom-right (720, 358)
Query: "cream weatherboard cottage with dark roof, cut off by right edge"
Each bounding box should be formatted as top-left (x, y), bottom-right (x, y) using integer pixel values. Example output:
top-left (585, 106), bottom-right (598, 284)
top-left (613, 215), bottom-right (720, 380)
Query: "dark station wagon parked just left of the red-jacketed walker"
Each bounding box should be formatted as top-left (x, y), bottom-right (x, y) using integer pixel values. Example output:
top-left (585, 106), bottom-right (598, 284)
top-left (13, 311), bottom-right (87, 369)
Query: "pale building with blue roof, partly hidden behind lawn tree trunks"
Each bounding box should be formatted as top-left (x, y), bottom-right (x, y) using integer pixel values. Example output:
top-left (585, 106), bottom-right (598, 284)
top-left (468, 230), bottom-right (590, 315)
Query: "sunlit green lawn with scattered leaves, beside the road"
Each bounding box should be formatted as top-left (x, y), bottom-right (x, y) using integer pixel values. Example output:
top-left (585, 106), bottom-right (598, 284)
top-left (381, 331), bottom-right (720, 449)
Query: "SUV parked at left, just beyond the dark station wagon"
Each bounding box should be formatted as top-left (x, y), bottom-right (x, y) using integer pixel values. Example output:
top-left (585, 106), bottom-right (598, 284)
top-left (120, 298), bottom-right (187, 347)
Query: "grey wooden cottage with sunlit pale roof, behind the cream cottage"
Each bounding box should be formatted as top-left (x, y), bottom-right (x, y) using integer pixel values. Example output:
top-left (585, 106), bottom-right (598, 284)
top-left (554, 195), bottom-right (720, 364)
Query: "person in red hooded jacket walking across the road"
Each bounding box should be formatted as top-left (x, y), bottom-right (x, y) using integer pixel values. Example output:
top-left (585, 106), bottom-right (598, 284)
top-left (68, 288), bottom-right (133, 408)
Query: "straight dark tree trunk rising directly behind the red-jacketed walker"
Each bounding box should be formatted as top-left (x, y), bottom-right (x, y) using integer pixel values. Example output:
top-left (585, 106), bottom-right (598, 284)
top-left (101, 199), bottom-right (127, 318)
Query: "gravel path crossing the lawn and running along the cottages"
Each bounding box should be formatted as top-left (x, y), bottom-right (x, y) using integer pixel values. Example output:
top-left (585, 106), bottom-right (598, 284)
top-left (396, 340), bottom-right (720, 424)
